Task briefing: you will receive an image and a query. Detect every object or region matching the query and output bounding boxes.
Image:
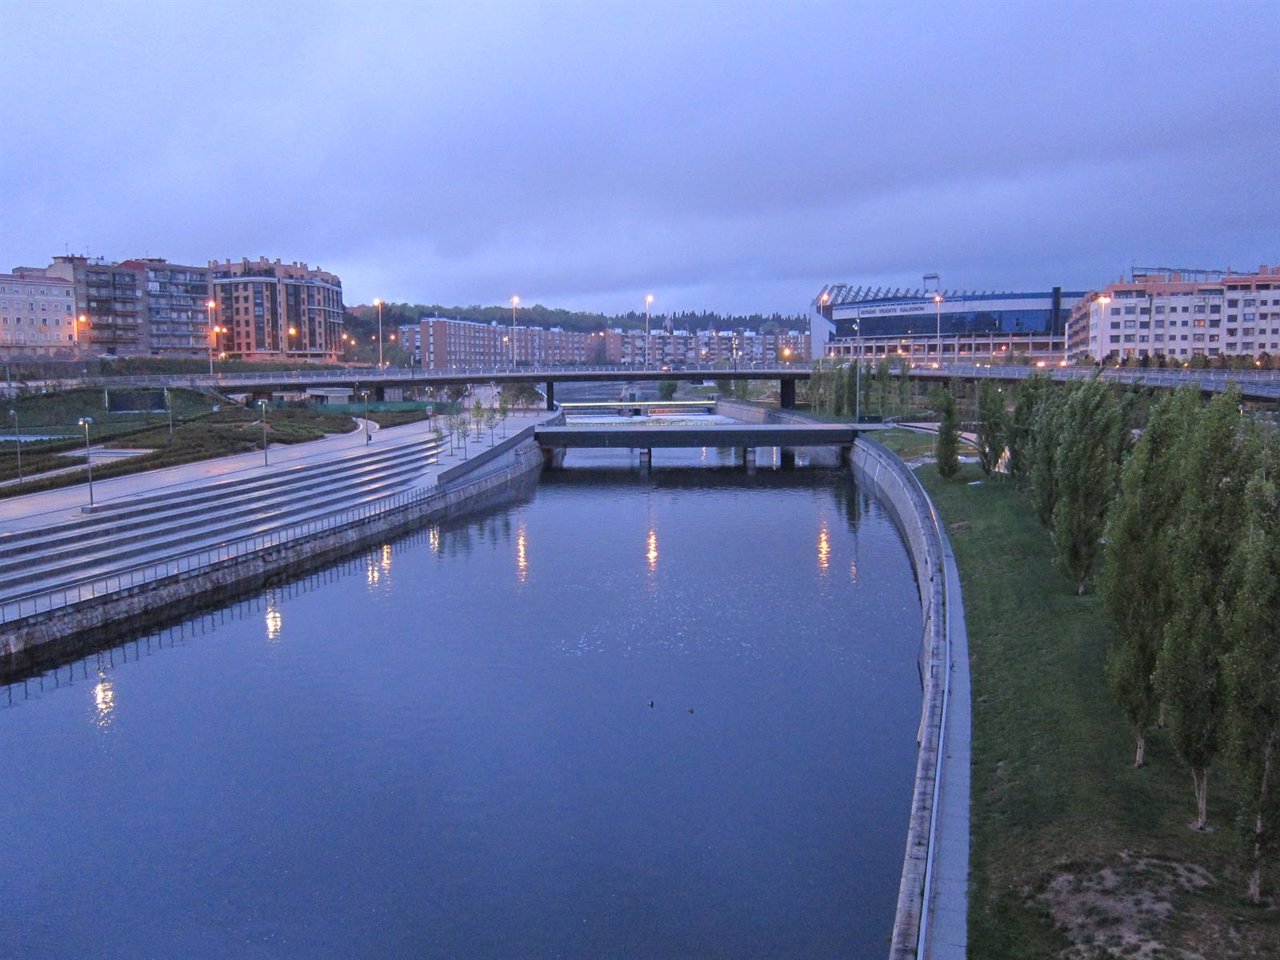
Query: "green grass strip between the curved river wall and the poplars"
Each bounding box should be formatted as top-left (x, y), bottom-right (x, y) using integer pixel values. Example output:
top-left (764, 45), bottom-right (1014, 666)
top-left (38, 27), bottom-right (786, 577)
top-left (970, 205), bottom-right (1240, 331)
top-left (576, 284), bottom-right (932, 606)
top-left (918, 465), bottom-right (1280, 960)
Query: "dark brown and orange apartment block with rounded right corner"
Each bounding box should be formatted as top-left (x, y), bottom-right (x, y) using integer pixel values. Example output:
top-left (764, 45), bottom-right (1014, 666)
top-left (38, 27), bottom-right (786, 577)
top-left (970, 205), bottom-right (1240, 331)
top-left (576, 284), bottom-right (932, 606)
top-left (209, 257), bottom-right (343, 362)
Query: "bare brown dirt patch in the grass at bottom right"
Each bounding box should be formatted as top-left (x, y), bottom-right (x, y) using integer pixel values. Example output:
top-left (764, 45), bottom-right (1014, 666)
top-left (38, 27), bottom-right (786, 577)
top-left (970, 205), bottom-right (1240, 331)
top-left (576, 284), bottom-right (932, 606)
top-left (1037, 852), bottom-right (1208, 960)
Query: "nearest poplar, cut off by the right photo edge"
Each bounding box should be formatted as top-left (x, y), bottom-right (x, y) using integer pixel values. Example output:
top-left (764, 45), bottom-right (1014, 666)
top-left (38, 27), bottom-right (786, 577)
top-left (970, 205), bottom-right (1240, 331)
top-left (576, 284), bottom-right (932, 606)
top-left (1221, 454), bottom-right (1280, 904)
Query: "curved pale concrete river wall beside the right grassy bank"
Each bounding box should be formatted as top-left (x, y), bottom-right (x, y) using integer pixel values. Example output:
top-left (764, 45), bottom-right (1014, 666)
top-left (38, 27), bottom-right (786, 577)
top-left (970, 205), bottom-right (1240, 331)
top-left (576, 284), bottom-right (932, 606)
top-left (716, 401), bottom-right (969, 960)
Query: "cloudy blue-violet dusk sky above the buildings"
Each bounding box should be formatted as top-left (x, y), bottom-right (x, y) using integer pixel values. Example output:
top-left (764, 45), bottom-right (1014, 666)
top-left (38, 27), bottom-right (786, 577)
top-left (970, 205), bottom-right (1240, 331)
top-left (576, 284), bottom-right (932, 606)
top-left (0, 0), bottom-right (1280, 314)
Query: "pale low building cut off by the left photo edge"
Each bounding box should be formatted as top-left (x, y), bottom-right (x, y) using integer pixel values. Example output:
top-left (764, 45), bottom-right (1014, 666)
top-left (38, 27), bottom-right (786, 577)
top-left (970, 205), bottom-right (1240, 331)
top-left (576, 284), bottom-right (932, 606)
top-left (0, 268), bottom-right (82, 360)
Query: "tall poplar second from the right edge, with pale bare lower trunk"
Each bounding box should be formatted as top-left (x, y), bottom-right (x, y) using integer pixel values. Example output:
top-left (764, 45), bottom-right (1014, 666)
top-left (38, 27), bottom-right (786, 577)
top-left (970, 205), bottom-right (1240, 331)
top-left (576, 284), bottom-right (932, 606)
top-left (1156, 390), bottom-right (1254, 829)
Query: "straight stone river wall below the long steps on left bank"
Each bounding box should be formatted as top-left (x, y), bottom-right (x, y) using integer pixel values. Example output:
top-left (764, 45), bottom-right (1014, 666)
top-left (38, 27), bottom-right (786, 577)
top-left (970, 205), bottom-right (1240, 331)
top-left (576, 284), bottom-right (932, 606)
top-left (0, 428), bottom-right (543, 673)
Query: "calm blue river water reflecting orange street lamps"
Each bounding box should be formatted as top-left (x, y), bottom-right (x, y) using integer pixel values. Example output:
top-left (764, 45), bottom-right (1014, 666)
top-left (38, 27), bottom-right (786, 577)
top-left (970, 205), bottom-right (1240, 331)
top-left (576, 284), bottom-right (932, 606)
top-left (0, 451), bottom-right (919, 959)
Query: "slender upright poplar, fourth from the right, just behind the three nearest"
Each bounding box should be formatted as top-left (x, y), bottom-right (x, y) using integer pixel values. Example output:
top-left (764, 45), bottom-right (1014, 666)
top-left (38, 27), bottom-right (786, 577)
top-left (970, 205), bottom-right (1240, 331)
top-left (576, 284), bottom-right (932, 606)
top-left (1052, 380), bottom-right (1120, 596)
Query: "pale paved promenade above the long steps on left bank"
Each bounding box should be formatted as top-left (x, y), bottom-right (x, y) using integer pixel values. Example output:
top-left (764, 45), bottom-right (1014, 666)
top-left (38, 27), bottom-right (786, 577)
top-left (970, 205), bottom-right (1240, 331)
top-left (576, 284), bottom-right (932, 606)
top-left (0, 410), bottom-right (553, 543)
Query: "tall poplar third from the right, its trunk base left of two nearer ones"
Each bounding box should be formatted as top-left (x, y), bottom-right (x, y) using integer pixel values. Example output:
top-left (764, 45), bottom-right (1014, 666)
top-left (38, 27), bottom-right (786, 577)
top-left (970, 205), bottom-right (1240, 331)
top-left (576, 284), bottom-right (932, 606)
top-left (1100, 389), bottom-right (1199, 767)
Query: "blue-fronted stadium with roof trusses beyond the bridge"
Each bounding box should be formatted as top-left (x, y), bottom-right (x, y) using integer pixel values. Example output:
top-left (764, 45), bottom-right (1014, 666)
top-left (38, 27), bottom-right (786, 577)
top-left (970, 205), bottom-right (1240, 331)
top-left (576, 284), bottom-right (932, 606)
top-left (810, 284), bottom-right (1084, 362)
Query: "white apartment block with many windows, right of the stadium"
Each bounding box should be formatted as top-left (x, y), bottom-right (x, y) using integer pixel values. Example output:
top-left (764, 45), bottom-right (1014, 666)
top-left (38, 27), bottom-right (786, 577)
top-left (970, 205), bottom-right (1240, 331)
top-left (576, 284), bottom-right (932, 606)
top-left (1069, 265), bottom-right (1280, 362)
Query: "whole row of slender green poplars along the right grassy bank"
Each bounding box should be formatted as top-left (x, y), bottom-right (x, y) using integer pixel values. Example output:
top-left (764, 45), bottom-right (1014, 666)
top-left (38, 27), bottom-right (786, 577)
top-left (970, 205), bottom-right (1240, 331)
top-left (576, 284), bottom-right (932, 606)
top-left (938, 378), bottom-right (1280, 902)
